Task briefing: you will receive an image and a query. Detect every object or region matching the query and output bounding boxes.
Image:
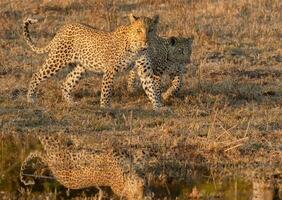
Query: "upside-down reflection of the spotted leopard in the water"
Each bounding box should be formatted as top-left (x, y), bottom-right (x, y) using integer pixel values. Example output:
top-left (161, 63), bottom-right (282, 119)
top-left (20, 133), bottom-right (153, 200)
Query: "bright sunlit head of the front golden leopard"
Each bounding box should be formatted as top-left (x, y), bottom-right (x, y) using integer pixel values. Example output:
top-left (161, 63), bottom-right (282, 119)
top-left (127, 14), bottom-right (159, 52)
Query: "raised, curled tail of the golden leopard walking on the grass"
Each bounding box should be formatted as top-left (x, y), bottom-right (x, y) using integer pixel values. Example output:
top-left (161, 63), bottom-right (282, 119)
top-left (23, 18), bottom-right (49, 54)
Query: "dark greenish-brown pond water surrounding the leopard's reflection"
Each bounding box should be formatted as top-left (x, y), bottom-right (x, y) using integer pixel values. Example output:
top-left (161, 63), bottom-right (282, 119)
top-left (0, 136), bottom-right (282, 200)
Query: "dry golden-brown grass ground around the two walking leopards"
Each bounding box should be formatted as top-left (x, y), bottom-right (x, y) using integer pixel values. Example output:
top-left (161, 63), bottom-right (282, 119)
top-left (0, 0), bottom-right (282, 198)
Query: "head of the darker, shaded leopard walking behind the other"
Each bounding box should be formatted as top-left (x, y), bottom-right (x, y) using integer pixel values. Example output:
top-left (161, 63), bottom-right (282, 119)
top-left (167, 37), bottom-right (194, 64)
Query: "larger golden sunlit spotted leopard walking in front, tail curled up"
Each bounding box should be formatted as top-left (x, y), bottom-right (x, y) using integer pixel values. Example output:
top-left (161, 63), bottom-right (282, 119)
top-left (23, 13), bottom-right (163, 109)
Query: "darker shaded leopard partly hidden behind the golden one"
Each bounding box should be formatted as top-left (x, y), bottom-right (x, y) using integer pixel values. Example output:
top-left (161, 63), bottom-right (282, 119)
top-left (127, 34), bottom-right (194, 101)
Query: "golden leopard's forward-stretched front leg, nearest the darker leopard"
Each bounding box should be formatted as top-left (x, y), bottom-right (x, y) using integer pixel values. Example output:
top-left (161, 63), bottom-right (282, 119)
top-left (136, 54), bottom-right (163, 110)
